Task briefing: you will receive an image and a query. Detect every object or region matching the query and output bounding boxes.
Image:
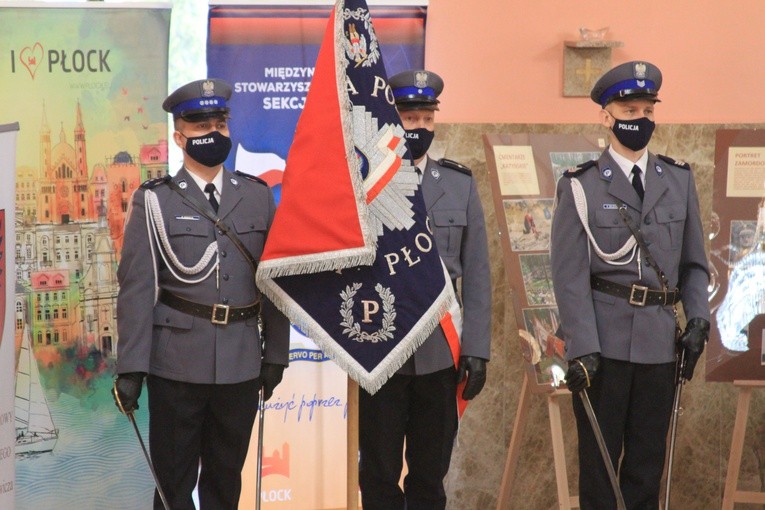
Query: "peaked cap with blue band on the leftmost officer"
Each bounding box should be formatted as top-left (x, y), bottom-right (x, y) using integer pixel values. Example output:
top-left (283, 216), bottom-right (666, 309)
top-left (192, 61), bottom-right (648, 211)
top-left (162, 78), bottom-right (231, 119)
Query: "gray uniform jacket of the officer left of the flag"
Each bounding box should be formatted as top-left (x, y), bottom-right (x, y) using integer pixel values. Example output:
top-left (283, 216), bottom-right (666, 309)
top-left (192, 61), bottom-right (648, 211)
top-left (117, 169), bottom-right (289, 384)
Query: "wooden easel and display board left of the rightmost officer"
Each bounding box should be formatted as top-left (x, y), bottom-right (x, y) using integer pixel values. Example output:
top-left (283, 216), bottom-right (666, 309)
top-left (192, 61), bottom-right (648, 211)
top-left (483, 133), bottom-right (606, 510)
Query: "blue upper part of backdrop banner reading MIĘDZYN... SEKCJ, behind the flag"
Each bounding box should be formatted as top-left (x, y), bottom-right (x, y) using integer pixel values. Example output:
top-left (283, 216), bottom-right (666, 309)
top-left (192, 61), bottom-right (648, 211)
top-left (207, 5), bottom-right (427, 201)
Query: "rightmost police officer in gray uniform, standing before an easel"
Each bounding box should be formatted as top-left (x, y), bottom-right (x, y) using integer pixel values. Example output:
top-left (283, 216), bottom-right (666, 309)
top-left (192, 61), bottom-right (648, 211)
top-left (550, 61), bottom-right (709, 509)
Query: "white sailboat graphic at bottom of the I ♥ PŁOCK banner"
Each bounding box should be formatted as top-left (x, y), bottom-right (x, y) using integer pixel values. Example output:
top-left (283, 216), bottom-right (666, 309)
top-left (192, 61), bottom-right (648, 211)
top-left (15, 323), bottom-right (58, 455)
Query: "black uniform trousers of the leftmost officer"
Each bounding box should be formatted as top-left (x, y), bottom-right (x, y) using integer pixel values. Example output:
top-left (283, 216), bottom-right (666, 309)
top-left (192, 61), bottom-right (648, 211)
top-left (146, 375), bottom-right (260, 510)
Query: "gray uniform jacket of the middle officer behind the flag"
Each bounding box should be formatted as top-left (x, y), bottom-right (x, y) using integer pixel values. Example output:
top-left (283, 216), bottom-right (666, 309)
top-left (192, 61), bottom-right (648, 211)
top-left (399, 158), bottom-right (491, 375)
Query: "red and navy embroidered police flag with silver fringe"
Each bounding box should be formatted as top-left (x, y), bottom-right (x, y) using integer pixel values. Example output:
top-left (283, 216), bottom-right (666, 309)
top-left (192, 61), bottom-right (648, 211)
top-left (257, 0), bottom-right (454, 393)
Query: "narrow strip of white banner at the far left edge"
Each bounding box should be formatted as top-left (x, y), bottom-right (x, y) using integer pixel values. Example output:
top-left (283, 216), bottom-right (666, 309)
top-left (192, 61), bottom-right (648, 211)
top-left (0, 121), bottom-right (19, 510)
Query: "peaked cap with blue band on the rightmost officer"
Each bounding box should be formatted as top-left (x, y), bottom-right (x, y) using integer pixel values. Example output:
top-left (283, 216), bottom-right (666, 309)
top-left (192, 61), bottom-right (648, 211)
top-left (590, 60), bottom-right (661, 108)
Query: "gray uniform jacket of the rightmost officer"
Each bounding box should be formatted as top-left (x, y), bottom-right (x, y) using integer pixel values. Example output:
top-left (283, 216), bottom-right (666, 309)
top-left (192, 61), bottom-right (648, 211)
top-left (550, 151), bottom-right (709, 363)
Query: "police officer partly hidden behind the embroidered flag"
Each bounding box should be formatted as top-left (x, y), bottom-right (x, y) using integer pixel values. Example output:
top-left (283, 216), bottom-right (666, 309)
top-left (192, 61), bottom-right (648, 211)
top-left (359, 70), bottom-right (491, 510)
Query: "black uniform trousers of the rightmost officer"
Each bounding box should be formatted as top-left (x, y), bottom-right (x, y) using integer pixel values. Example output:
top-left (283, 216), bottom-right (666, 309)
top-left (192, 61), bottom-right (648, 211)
top-left (573, 358), bottom-right (675, 510)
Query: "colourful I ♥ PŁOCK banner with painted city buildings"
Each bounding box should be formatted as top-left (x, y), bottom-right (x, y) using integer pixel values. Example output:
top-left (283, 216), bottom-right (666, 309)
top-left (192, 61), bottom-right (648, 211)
top-left (0, 2), bottom-right (170, 510)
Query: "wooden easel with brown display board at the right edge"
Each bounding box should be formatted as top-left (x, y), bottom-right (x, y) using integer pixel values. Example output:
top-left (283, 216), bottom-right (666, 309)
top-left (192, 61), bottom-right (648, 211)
top-left (706, 129), bottom-right (765, 510)
